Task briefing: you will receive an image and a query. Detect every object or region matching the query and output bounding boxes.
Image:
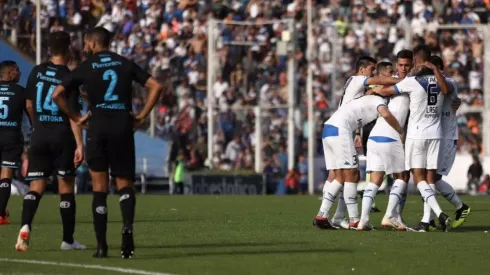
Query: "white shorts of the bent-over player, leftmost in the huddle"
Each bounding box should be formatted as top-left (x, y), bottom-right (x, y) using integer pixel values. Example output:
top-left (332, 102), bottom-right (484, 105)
top-left (322, 136), bottom-right (359, 170)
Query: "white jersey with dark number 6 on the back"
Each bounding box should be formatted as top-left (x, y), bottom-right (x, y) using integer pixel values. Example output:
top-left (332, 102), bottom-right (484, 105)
top-left (395, 75), bottom-right (444, 139)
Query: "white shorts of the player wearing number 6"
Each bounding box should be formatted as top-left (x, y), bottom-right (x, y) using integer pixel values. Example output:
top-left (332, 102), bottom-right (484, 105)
top-left (405, 138), bottom-right (441, 170)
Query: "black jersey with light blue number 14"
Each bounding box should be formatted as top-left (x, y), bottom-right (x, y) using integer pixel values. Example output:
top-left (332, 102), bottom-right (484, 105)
top-left (26, 62), bottom-right (80, 134)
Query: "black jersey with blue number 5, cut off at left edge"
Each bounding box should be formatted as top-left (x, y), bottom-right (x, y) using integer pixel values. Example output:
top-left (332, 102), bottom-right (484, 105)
top-left (0, 81), bottom-right (25, 133)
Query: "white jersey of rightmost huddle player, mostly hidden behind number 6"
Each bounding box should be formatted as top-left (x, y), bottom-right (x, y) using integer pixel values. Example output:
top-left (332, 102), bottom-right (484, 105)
top-left (441, 77), bottom-right (458, 140)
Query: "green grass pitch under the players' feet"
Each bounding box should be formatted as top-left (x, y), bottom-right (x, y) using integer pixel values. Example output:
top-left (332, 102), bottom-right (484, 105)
top-left (0, 195), bottom-right (490, 275)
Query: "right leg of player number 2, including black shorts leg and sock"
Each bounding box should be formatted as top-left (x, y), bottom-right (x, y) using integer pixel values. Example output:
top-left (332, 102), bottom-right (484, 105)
top-left (108, 131), bottom-right (136, 259)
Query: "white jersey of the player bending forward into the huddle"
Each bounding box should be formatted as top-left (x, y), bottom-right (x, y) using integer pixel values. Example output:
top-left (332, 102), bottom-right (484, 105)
top-left (323, 95), bottom-right (386, 137)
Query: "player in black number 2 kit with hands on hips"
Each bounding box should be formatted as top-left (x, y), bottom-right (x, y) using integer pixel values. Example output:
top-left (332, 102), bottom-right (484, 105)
top-left (52, 27), bottom-right (162, 258)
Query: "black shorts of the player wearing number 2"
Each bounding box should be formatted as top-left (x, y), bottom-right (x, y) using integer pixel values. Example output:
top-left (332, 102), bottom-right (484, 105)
top-left (86, 118), bottom-right (136, 180)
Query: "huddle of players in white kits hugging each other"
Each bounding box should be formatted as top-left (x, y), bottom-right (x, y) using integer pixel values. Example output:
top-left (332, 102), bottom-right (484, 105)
top-left (313, 45), bottom-right (471, 232)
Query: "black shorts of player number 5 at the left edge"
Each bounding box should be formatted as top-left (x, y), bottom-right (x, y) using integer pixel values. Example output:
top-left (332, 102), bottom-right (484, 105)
top-left (0, 131), bottom-right (24, 169)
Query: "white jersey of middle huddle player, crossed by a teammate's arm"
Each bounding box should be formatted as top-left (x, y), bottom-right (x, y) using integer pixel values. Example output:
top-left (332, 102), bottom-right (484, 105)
top-left (369, 94), bottom-right (410, 142)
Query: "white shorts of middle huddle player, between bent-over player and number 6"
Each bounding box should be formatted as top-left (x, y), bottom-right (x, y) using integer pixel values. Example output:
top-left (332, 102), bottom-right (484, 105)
top-left (366, 139), bottom-right (405, 175)
